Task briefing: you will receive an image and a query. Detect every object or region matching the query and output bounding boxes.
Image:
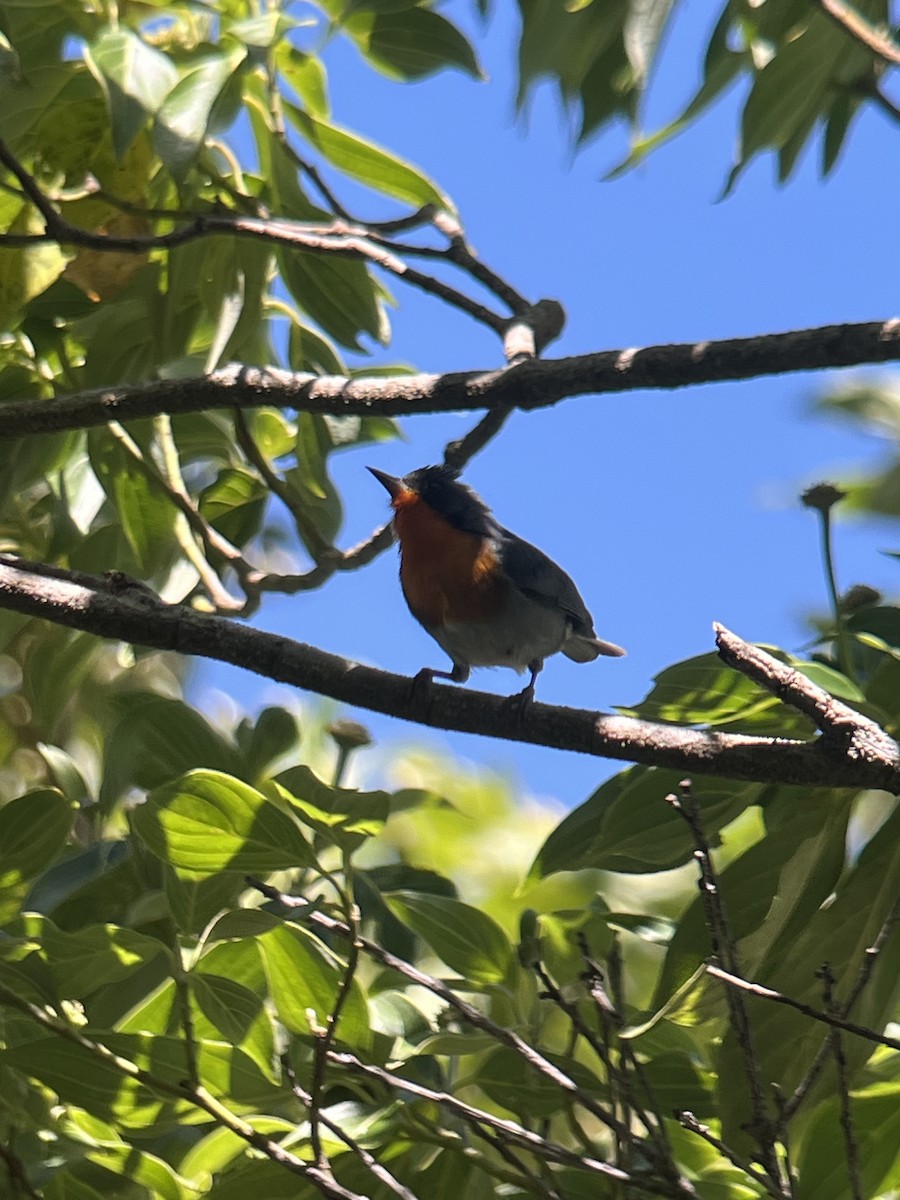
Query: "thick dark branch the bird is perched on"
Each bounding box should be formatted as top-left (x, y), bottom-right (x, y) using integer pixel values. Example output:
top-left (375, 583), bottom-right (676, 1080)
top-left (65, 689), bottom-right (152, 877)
top-left (0, 559), bottom-right (900, 793)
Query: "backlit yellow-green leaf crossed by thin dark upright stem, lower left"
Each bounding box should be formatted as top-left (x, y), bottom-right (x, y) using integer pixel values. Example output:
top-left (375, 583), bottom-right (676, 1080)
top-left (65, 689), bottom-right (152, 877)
top-left (257, 923), bottom-right (371, 1049)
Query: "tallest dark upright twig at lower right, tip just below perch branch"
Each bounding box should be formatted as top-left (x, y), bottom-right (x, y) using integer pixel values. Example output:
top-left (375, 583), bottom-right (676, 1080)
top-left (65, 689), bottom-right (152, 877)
top-left (666, 780), bottom-right (784, 1195)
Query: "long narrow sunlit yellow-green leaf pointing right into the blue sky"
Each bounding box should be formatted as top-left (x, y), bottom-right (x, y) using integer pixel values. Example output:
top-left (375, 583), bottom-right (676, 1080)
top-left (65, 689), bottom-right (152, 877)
top-left (284, 102), bottom-right (452, 208)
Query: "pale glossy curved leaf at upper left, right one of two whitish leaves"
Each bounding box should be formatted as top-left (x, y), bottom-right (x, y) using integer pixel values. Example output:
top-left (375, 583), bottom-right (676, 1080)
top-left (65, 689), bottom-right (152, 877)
top-left (152, 49), bottom-right (247, 182)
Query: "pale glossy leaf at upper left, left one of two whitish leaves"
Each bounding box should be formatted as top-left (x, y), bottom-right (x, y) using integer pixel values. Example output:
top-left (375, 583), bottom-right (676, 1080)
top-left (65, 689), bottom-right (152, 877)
top-left (84, 25), bottom-right (178, 158)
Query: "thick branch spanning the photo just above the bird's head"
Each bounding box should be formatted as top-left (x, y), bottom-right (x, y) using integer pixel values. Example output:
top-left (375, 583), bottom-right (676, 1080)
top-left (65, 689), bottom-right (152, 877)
top-left (0, 318), bottom-right (900, 438)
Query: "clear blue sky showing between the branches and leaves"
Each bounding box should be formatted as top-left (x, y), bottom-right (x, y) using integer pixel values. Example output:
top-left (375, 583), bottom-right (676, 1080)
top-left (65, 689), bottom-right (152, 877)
top-left (194, 0), bottom-right (900, 808)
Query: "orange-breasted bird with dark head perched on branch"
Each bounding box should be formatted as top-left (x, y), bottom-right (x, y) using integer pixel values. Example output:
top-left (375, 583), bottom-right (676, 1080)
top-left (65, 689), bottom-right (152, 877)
top-left (368, 466), bottom-right (625, 710)
